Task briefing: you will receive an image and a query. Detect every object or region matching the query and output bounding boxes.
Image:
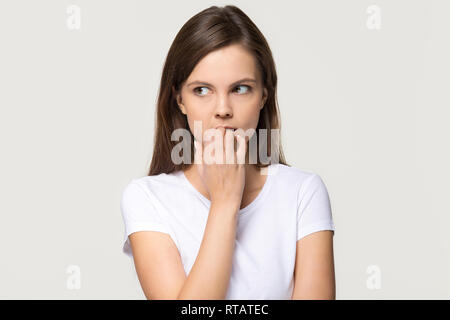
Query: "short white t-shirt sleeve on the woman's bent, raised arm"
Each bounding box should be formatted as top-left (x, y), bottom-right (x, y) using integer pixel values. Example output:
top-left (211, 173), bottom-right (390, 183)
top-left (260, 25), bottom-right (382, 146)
top-left (120, 180), bottom-right (170, 258)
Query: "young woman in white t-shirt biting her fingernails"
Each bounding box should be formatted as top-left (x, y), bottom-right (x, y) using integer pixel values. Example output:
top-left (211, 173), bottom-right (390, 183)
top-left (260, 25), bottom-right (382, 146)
top-left (121, 6), bottom-right (335, 299)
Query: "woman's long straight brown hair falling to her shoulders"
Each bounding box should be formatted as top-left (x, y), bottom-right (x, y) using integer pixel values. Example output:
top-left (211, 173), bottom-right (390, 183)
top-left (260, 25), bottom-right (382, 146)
top-left (148, 5), bottom-right (289, 176)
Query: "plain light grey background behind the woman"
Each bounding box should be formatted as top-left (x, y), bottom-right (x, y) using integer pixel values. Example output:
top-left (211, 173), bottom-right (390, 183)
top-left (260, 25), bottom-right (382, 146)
top-left (0, 0), bottom-right (450, 299)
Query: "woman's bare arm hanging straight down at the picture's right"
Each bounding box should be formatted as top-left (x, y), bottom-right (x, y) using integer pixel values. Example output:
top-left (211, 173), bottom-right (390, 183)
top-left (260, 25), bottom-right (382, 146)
top-left (292, 230), bottom-right (336, 300)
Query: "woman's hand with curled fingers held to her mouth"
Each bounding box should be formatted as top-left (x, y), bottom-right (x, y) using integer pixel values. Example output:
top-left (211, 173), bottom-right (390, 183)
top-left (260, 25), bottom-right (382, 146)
top-left (194, 127), bottom-right (247, 208)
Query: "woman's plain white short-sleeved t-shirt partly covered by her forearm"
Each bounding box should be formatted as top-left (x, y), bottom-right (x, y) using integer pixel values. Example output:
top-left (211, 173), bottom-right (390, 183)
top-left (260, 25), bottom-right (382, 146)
top-left (121, 163), bottom-right (334, 300)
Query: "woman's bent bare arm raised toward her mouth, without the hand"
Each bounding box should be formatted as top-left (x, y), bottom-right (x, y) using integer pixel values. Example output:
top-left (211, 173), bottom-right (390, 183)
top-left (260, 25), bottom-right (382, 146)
top-left (130, 202), bottom-right (239, 300)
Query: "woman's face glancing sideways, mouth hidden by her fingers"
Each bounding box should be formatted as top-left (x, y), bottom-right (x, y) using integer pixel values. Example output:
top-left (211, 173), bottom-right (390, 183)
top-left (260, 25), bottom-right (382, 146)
top-left (177, 44), bottom-right (267, 142)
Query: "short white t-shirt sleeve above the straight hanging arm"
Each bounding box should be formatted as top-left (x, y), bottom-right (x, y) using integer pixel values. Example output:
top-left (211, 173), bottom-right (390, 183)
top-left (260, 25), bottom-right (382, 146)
top-left (297, 173), bottom-right (335, 240)
